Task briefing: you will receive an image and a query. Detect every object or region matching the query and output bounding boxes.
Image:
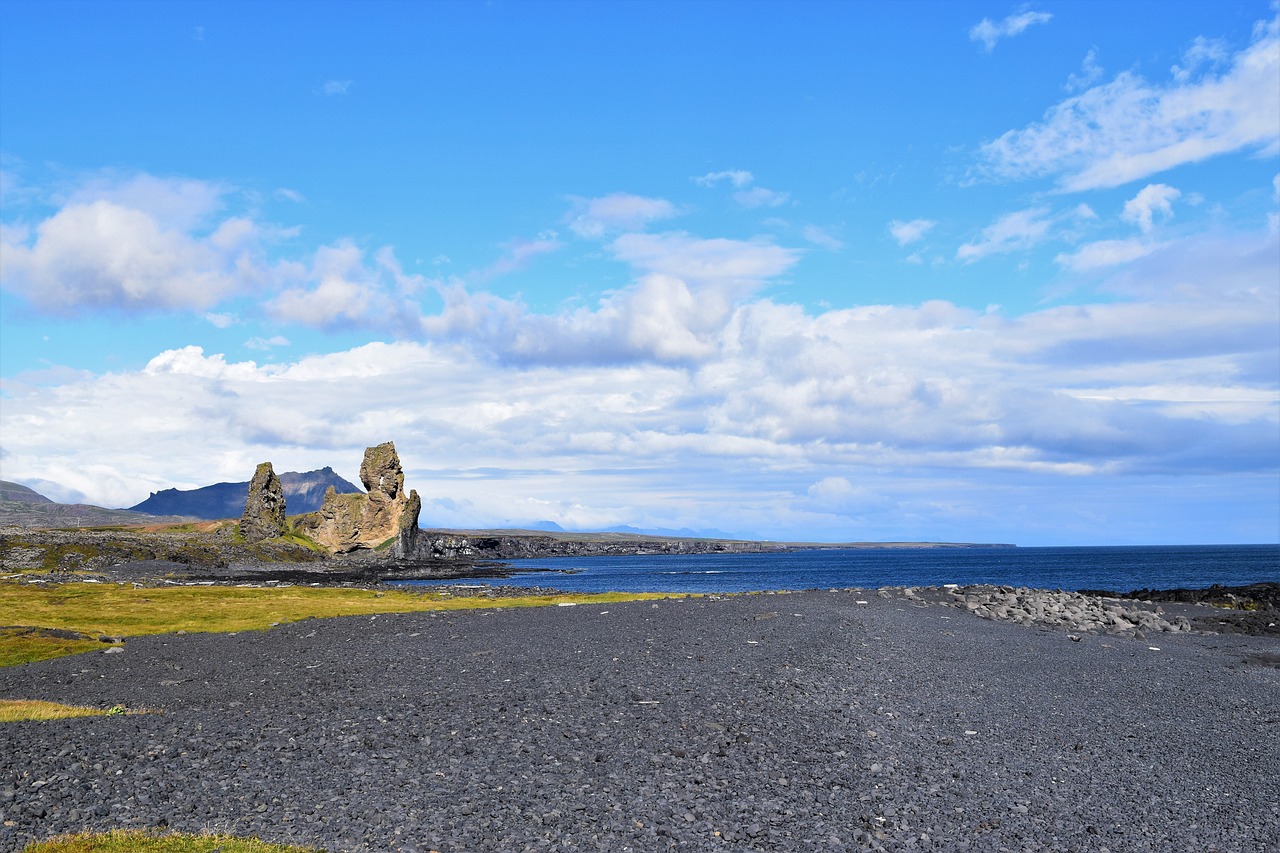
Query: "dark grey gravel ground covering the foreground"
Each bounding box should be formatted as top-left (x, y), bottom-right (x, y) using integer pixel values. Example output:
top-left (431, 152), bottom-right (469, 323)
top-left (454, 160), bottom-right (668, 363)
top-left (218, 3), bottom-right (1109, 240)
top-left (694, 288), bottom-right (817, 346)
top-left (0, 590), bottom-right (1280, 853)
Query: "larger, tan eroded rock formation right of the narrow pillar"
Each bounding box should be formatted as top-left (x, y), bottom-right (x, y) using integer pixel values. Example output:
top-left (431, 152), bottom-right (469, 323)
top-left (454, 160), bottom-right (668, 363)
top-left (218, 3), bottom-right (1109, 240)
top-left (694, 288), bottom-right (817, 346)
top-left (297, 442), bottom-right (422, 556)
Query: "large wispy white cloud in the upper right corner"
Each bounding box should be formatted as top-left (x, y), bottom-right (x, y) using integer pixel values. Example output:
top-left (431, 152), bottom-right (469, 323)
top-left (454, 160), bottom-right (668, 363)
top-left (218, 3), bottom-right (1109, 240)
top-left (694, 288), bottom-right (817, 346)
top-left (980, 12), bottom-right (1280, 192)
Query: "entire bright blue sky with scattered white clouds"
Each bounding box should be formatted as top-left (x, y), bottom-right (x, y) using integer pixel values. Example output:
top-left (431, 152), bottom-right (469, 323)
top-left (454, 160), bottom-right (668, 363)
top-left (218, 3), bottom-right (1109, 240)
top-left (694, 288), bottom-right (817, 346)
top-left (0, 0), bottom-right (1280, 544)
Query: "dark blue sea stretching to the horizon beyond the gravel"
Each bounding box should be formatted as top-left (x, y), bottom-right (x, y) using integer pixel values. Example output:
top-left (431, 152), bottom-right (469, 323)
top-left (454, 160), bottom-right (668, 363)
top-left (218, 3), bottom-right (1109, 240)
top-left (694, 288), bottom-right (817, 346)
top-left (394, 544), bottom-right (1280, 593)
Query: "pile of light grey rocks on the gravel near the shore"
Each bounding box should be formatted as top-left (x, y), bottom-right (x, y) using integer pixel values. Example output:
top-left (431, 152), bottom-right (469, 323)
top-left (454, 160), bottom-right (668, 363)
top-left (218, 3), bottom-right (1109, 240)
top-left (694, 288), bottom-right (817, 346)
top-left (921, 584), bottom-right (1192, 639)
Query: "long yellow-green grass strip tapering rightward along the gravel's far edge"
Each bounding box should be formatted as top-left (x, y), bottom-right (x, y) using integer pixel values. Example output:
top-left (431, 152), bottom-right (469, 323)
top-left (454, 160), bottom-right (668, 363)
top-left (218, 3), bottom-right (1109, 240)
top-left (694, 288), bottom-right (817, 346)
top-left (0, 581), bottom-right (672, 666)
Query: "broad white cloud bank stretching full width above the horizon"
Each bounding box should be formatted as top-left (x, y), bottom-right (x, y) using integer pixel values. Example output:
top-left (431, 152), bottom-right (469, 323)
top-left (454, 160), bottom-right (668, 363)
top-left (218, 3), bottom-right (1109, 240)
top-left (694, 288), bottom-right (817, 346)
top-left (0, 225), bottom-right (1280, 538)
